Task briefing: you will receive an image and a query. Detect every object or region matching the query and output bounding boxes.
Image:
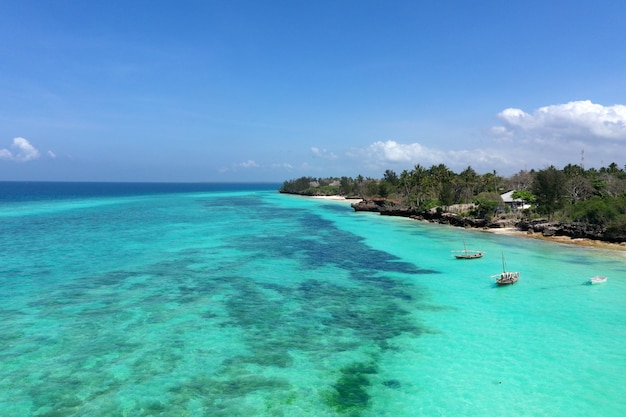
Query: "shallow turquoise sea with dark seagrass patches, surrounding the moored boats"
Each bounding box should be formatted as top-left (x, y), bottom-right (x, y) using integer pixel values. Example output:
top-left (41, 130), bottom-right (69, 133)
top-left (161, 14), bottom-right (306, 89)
top-left (0, 185), bottom-right (626, 417)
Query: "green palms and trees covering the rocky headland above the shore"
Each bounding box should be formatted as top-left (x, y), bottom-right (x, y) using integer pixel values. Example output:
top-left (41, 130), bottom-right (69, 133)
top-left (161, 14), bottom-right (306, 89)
top-left (280, 163), bottom-right (626, 231)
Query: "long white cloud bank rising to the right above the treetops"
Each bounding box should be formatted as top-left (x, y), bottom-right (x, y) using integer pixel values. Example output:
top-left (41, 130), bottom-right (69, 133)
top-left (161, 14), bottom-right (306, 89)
top-left (292, 101), bottom-right (626, 176)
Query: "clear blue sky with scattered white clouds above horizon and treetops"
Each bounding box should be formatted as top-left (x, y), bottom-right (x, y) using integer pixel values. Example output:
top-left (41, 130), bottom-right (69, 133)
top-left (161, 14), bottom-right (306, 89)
top-left (0, 0), bottom-right (626, 182)
